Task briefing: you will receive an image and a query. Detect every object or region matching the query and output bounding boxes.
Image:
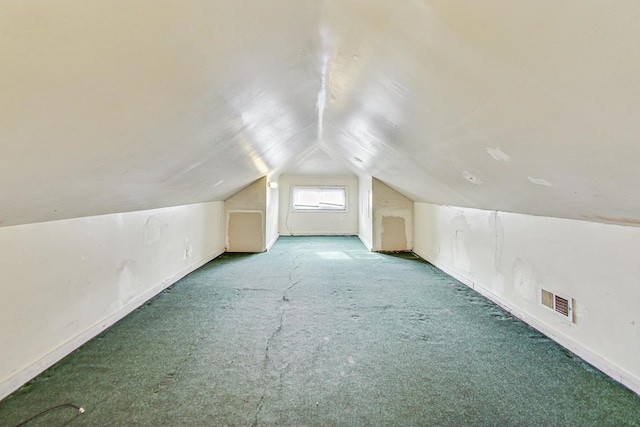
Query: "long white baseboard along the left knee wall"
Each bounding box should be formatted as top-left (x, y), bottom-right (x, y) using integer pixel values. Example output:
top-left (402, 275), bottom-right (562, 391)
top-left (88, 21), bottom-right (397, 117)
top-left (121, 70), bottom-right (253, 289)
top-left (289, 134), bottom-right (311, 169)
top-left (0, 250), bottom-right (224, 400)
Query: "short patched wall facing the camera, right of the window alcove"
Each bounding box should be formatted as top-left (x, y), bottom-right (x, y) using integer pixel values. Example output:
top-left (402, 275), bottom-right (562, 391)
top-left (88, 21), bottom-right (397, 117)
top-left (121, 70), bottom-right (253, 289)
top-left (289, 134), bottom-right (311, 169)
top-left (373, 178), bottom-right (413, 251)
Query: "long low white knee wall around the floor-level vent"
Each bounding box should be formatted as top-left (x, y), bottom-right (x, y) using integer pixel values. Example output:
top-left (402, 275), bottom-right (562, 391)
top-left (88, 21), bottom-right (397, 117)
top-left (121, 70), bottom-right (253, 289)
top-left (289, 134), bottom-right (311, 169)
top-left (414, 203), bottom-right (640, 393)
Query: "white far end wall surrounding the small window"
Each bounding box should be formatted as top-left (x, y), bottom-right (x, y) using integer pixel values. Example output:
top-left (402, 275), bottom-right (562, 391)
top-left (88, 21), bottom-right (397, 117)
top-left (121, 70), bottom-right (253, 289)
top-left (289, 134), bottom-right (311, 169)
top-left (278, 175), bottom-right (359, 236)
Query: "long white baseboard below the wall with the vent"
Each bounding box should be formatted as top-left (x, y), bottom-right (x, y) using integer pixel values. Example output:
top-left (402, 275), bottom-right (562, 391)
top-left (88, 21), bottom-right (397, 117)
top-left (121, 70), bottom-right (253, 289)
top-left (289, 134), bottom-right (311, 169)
top-left (413, 248), bottom-right (640, 395)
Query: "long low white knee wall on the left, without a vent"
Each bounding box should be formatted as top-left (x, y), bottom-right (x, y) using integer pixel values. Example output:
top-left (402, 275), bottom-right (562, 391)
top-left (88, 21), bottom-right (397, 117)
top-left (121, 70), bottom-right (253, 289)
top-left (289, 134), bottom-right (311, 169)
top-left (0, 202), bottom-right (224, 399)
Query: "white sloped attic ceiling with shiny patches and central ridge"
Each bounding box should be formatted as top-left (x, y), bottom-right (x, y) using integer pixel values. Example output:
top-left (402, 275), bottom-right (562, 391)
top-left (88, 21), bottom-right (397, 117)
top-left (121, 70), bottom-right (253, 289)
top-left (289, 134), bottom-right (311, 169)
top-left (0, 0), bottom-right (640, 226)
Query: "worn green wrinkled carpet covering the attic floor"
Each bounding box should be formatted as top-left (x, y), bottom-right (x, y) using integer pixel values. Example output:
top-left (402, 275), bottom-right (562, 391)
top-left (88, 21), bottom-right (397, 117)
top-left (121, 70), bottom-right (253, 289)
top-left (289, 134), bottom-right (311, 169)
top-left (0, 237), bottom-right (640, 426)
